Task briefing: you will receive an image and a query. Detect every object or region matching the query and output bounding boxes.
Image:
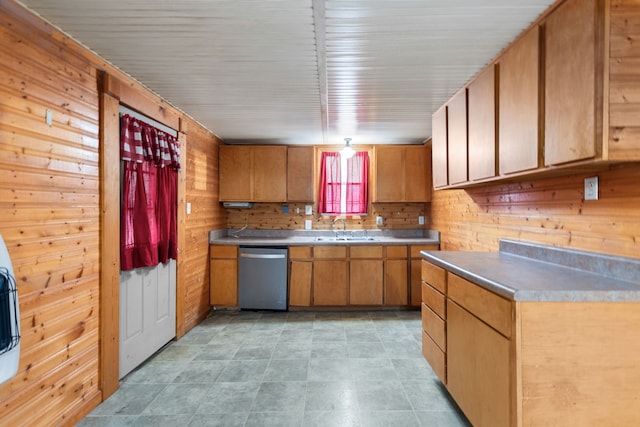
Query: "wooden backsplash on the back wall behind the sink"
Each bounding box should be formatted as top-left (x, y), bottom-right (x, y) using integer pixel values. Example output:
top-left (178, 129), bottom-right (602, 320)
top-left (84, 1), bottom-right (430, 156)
top-left (227, 203), bottom-right (429, 230)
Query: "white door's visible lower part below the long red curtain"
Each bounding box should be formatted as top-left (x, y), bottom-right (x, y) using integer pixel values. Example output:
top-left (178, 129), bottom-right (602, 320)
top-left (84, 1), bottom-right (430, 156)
top-left (120, 260), bottom-right (176, 378)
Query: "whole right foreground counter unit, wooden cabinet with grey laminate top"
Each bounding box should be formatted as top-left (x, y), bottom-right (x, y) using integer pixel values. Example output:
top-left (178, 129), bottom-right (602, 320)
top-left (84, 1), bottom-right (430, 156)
top-left (421, 240), bottom-right (640, 427)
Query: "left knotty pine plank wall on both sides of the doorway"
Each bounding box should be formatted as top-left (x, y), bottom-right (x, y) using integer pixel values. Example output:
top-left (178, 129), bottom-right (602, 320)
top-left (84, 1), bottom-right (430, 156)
top-left (0, 0), bottom-right (226, 426)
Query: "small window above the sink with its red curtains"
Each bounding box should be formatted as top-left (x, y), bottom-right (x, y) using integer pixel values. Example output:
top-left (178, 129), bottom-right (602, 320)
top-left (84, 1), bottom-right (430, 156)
top-left (318, 151), bottom-right (369, 215)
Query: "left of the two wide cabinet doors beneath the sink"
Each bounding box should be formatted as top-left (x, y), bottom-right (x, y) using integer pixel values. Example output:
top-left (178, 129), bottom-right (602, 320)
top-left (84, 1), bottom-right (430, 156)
top-left (313, 260), bottom-right (348, 306)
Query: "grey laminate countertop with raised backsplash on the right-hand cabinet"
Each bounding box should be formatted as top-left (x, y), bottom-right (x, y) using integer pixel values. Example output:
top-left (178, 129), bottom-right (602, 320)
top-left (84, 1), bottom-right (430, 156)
top-left (421, 240), bottom-right (640, 302)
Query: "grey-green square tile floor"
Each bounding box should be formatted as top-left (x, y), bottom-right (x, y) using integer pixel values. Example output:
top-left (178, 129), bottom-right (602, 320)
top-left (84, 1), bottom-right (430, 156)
top-left (78, 311), bottom-right (470, 427)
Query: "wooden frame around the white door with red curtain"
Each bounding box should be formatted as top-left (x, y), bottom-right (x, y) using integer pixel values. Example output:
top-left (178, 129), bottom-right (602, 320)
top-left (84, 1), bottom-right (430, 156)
top-left (97, 72), bottom-right (187, 401)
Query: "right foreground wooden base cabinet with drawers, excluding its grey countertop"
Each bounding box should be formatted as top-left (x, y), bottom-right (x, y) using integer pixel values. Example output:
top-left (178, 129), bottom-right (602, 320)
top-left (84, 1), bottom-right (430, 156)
top-left (422, 261), bottom-right (640, 427)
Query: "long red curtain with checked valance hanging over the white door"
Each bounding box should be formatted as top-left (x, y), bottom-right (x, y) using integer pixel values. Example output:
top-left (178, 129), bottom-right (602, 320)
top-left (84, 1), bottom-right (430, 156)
top-left (120, 114), bottom-right (180, 270)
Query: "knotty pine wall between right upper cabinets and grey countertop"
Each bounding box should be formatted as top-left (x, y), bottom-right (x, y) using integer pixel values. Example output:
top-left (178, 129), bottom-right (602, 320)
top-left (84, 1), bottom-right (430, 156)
top-left (430, 164), bottom-right (640, 258)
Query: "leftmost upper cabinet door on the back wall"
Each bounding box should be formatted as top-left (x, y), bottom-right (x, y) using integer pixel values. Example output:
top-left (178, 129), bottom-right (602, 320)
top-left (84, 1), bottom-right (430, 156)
top-left (218, 145), bottom-right (252, 202)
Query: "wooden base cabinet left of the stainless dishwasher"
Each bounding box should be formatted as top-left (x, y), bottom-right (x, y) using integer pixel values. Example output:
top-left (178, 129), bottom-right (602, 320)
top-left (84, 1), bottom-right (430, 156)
top-left (209, 245), bottom-right (238, 307)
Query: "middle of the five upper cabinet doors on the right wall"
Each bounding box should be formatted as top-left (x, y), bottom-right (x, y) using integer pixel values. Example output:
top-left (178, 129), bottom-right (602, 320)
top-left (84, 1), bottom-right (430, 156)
top-left (468, 66), bottom-right (497, 181)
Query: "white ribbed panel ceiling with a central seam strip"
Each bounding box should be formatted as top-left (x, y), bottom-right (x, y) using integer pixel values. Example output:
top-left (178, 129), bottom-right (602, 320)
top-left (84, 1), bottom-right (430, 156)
top-left (21, 0), bottom-right (554, 144)
